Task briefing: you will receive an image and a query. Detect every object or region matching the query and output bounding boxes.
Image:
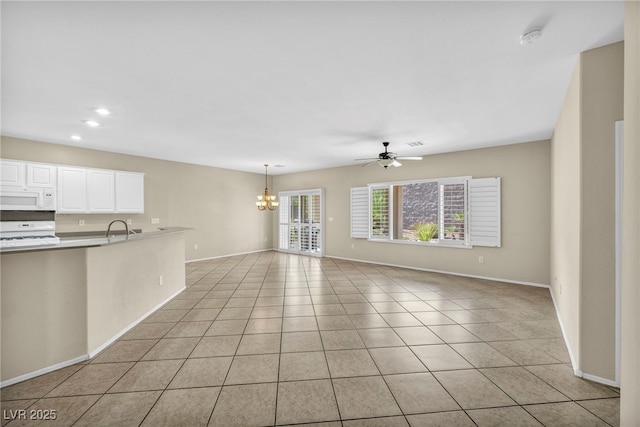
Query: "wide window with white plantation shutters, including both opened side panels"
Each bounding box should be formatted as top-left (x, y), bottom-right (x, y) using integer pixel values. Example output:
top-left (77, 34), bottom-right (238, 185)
top-left (351, 177), bottom-right (500, 246)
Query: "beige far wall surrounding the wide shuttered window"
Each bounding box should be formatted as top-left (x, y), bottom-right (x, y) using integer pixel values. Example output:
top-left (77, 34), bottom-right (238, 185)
top-left (273, 141), bottom-right (550, 284)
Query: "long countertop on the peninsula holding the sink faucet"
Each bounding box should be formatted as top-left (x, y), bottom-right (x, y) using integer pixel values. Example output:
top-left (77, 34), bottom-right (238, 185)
top-left (0, 227), bottom-right (191, 254)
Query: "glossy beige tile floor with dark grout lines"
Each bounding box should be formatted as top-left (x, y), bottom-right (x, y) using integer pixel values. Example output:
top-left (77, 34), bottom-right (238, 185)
top-left (1, 252), bottom-right (619, 426)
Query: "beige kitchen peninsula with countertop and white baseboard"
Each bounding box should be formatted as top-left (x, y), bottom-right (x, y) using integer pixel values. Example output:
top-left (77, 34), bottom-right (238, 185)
top-left (1, 227), bottom-right (189, 386)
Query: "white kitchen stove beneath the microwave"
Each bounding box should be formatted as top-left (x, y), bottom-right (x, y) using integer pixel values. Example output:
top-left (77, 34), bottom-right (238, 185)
top-left (0, 215), bottom-right (60, 248)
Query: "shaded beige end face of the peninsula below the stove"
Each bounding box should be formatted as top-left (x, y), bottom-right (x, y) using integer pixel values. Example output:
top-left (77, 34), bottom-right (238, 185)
top-left (0, 249), bottom-right (87, 381)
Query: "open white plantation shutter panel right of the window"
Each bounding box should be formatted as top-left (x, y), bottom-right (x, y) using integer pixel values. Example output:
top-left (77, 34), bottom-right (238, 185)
top-left (468, 177), bottom-right (501, 248)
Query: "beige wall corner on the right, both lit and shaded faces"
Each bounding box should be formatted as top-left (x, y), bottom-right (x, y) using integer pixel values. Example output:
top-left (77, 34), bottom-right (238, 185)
top-left (550, 43), bottom-right (624, 382)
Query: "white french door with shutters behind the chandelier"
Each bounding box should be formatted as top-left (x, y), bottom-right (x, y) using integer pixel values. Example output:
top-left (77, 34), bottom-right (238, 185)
top-left (278, 189), bottom-right (324, 256)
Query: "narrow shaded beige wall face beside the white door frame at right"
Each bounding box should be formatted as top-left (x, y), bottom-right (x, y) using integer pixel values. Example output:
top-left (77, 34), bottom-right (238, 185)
top-left (580, 43), bottom-right (624, 380)
